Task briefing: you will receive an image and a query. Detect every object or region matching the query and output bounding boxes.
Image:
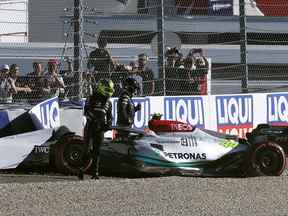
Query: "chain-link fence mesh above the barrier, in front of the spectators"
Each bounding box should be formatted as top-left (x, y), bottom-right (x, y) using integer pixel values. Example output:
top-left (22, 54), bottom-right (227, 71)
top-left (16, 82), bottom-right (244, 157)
top-left (0, 0), bottom-right (288, 103)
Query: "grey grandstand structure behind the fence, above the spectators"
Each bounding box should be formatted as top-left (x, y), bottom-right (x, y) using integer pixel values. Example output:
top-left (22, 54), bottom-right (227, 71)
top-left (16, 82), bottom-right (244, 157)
top-left (0, 0), bottom-right (288, 99)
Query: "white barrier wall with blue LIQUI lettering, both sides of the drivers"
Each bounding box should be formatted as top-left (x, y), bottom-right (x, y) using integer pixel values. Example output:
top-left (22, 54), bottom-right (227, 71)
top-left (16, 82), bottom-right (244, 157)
top-left (0, 92), bottom-right (288, 137)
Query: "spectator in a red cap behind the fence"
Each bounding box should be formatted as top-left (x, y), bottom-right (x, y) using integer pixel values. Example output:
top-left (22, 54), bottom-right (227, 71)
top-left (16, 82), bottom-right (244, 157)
top-left (43, 59), bottom-right (65, 97)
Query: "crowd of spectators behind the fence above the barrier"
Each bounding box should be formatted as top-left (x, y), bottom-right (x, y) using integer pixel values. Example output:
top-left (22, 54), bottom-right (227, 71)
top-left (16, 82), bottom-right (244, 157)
top-left (0, 47), bottom-right (209, 104)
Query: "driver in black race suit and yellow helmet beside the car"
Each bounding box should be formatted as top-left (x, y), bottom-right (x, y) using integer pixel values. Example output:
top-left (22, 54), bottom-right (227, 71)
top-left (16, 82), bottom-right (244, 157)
top-left (78, 79), bottom-right (114, 179)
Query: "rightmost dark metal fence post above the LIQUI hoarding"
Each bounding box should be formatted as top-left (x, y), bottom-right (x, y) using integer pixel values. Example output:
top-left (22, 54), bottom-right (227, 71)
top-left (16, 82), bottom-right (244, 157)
top-left (239, 0), bottom-right (248, 93)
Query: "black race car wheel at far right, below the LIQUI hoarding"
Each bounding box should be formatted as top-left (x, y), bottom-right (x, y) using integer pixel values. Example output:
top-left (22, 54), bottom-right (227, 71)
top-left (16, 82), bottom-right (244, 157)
top-left (250, 142), bottom-right (286, 176)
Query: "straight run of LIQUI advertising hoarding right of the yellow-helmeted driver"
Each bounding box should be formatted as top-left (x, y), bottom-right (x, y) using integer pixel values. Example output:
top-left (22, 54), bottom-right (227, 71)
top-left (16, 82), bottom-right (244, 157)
top-left (112, 92), bottom-right (288, 137)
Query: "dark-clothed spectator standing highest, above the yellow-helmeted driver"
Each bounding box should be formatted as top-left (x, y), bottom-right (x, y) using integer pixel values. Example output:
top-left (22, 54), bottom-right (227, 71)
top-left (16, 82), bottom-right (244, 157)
top-left (87, 37), bottom-right (114, 73)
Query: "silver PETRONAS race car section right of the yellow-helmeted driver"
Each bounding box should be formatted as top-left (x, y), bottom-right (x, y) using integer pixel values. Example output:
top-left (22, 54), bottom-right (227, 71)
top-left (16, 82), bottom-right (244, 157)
top-left (100, 116), bottom-right (287, 176)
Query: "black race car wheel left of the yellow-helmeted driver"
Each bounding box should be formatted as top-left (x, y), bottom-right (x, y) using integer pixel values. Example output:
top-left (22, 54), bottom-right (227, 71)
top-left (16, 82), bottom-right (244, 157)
top-left (55, 134), bottom-right (92, 174)
